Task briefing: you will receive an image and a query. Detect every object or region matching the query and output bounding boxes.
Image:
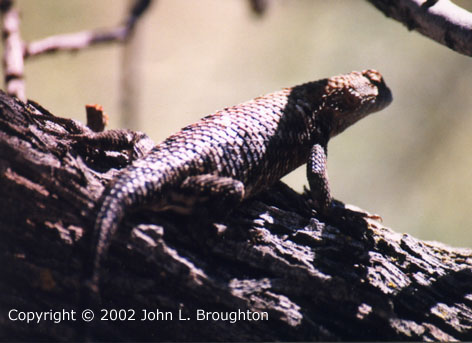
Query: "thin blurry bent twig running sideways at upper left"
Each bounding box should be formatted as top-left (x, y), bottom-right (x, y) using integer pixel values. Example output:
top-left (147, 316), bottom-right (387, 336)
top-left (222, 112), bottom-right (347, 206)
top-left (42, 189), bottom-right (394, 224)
top-left (24, 0), bottom-right (152, 58)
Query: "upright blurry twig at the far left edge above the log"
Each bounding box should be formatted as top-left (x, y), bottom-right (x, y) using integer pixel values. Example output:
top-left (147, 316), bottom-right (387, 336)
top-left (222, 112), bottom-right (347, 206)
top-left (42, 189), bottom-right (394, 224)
top-left (0, 0), bottom-right (26, 101)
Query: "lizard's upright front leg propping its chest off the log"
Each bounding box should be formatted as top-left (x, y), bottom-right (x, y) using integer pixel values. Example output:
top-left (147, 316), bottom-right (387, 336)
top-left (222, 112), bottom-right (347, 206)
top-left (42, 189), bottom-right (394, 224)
top-left (307, 144), bottom-right (332, 214)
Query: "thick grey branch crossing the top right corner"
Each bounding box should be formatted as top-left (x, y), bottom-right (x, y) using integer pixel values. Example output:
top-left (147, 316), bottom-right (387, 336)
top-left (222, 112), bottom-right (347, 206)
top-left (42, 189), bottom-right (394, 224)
top-left (368, 0), bottom-right (472, 56)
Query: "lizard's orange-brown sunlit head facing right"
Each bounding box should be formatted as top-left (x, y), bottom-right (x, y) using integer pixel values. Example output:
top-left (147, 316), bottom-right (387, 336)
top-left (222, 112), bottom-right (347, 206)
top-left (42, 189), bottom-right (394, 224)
top-left (322, 69), bottom-right (392, 137)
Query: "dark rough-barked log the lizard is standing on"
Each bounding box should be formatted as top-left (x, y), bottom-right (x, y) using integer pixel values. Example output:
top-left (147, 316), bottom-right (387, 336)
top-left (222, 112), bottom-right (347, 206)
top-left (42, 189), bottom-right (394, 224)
top-left (0, 93), bottom-right (472, 341)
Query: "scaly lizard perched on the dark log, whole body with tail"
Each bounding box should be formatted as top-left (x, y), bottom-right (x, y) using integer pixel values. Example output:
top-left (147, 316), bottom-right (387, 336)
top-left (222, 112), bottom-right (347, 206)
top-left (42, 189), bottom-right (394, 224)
top-left (85, 69), bottom-right (392, 295)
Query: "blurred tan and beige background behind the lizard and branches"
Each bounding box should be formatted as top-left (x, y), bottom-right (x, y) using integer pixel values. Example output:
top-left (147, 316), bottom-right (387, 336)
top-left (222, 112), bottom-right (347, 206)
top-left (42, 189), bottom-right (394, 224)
top-left (3, 0), bottom-right (472, 247)
